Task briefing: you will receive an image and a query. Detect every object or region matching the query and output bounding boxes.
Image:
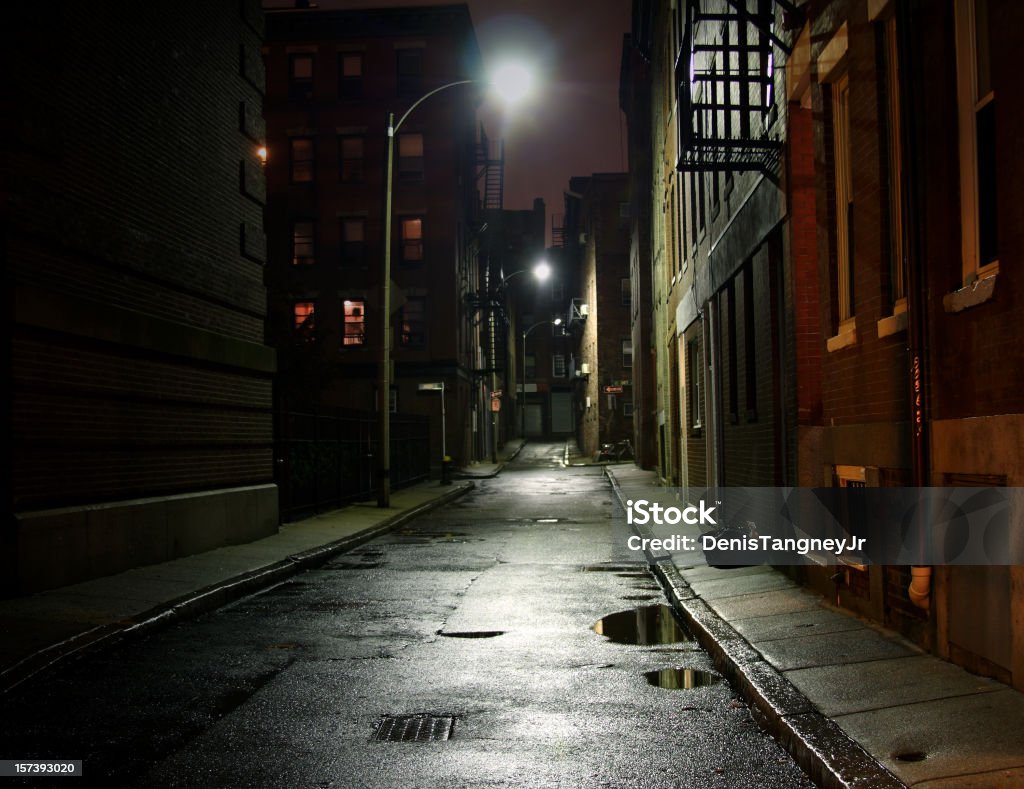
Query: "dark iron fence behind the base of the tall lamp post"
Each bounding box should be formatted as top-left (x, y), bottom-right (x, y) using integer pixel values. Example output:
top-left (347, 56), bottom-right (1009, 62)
top-left (275, 407), bottom-right (430, 522)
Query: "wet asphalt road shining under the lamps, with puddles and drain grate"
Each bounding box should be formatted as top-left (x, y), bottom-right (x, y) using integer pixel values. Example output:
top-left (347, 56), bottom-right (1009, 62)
top-left (0, 444), bottom-right (811, 789)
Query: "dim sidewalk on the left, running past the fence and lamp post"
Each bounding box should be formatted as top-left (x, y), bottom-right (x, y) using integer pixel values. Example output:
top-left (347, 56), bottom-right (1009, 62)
top-left (0, 481), bottom-right (473, 694)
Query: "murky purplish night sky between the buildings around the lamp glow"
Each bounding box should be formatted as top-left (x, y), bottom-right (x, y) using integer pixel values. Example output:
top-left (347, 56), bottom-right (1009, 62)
top-left (266, 0), bottom-right (631, 237)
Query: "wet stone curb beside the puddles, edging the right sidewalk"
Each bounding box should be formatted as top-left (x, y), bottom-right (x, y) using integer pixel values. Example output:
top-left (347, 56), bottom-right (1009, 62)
top-left (604, 470), bottom-right (906, 789)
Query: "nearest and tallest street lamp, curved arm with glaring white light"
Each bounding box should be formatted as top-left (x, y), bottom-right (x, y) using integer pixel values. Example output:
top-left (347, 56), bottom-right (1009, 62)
top-left (377, 64), bottom-right (529, 508)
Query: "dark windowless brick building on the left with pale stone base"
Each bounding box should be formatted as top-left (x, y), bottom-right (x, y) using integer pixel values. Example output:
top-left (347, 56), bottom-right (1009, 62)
top-left (0, 0), bottom-right (278, 594)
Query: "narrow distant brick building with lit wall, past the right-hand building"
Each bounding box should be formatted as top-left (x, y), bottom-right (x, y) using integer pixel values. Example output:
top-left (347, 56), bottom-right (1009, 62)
top-left (569, 173), bottom-right (633, 454)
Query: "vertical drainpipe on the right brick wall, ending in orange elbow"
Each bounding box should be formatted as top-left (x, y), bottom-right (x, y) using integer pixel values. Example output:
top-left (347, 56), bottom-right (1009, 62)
top-left (896, 3), bottom-right (932, 611)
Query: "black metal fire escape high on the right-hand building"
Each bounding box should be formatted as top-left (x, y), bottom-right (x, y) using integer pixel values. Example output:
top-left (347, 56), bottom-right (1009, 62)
top-left (675, 0), bottom-right (800, 173)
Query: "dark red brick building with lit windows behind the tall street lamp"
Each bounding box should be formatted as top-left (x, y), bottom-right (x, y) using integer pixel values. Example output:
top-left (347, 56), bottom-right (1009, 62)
top-left (264, 5), bottom-right (485, 466)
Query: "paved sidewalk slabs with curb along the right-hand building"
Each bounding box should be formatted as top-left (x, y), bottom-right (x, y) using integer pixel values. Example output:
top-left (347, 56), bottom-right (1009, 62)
top-left (606, 465), bottom-right (1024, 789)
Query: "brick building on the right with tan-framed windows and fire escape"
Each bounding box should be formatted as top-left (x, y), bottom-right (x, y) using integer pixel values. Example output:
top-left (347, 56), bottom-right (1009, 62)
top-left (627, 0), bottom-right (1024, 687)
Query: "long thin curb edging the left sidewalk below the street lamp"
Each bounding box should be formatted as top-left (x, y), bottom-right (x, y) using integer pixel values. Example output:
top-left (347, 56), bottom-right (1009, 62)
top-left (0, 482), bottom-right (475, 696)
